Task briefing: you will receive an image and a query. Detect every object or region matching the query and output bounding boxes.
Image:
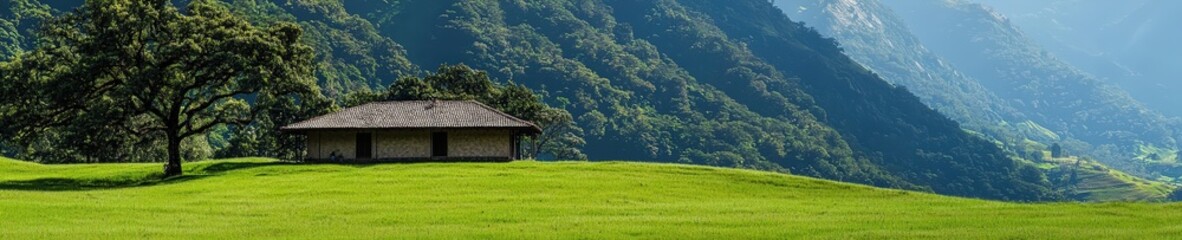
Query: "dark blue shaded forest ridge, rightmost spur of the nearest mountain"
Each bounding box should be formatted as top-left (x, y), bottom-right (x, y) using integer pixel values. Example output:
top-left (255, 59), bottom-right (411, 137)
top-left (661, 1), bottom-right (1059, 200)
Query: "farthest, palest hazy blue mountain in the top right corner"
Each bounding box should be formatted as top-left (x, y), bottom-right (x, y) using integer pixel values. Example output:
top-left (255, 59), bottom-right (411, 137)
top-left (979, 0), bottom-right (1182, 117)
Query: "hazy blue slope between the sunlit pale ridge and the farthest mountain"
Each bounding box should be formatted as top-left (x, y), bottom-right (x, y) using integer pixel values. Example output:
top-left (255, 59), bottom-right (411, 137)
top-left (883, 0), bottom-right (1177, 182)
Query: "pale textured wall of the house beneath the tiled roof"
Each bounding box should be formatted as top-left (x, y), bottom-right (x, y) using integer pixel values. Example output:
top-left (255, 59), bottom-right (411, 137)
top-left (306, 129), bottom-right (513, 160)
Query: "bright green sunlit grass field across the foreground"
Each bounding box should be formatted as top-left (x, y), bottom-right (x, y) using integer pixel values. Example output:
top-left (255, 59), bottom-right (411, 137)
top-left (0, 158), bottom-right (1182, 239)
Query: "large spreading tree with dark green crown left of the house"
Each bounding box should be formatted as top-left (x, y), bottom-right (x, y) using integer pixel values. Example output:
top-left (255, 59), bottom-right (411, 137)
top-left (0, 0), bottom-right (318, 177)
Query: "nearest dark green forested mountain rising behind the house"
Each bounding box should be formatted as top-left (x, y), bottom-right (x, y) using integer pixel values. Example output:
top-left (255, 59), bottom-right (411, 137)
top-left (0, 0), bottom-right (1058, 201)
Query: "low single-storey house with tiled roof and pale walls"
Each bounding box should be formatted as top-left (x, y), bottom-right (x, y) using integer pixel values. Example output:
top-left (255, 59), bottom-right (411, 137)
top-left (280, 100), bottom-right (541, 162)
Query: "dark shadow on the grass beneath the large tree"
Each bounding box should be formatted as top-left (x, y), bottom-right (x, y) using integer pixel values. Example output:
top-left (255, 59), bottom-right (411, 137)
top-left (0, 162), bottom-right (284, 192)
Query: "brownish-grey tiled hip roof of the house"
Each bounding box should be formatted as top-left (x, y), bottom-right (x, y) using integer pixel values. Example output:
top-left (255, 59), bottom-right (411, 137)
top-left (281, 100), bottom-right (541, 131)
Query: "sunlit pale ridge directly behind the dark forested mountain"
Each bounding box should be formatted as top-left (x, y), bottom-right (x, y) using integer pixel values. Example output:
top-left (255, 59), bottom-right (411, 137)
top-left (775, 0), bottom-right (1164, 200)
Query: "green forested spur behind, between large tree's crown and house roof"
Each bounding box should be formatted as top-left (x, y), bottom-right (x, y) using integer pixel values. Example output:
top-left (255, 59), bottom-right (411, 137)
top-left (218, 0), bottom-right (418, 98)
